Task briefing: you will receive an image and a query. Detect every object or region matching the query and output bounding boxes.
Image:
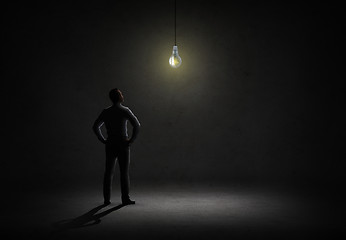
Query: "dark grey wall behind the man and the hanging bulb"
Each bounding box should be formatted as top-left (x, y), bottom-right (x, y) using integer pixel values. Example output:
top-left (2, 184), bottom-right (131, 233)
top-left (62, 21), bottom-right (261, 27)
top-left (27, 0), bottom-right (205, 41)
top-left (2, 1), bottom-right (344, 188)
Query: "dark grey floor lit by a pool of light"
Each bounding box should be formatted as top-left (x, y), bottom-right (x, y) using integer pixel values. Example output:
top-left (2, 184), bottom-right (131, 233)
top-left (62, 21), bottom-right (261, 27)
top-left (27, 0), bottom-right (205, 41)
top-left (2, 185), bottom-right (345, 239)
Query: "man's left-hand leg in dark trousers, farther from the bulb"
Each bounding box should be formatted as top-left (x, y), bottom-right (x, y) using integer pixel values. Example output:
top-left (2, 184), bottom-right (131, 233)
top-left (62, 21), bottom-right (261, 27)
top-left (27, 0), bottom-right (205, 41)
top-left (103, 144), bottom-right (117, 204)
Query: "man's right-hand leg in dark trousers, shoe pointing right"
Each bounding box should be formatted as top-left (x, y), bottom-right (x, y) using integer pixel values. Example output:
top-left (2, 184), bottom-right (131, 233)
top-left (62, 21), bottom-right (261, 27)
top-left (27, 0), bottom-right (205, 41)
top-left (118, 147), bottom-right (134, 204)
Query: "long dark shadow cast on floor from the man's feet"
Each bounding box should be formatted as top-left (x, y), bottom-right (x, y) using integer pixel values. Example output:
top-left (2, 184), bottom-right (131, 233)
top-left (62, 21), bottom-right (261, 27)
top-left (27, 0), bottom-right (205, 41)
top-left (52, 204), bottom-right (126, 232)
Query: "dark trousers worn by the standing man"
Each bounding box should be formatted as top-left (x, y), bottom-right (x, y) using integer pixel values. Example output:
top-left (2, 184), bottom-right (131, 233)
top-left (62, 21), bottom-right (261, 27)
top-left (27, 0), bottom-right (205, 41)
top-left (103, 141), bottom-right (130, 201)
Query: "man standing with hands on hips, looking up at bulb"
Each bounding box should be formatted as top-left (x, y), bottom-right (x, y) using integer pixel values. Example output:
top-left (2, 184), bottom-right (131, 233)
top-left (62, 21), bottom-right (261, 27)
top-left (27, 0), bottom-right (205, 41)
top-left (93, 88), bottom-right (140, 205)
